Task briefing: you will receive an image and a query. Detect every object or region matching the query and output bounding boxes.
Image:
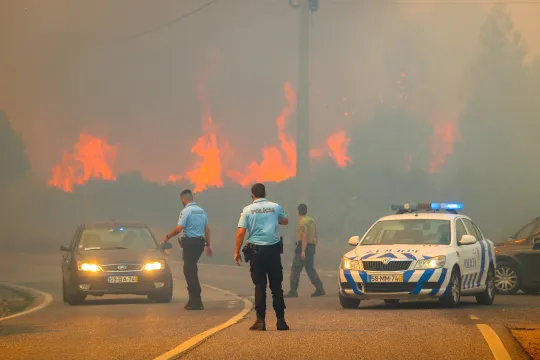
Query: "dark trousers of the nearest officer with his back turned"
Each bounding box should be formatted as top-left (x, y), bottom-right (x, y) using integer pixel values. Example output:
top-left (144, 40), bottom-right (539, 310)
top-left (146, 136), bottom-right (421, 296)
top-left (249, 243), bottom-right (285, 319)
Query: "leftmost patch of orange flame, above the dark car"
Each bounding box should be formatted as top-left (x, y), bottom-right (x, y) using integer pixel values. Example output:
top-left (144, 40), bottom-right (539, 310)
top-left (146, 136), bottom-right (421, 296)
top-left (49, 133), bottom-right (118, 192)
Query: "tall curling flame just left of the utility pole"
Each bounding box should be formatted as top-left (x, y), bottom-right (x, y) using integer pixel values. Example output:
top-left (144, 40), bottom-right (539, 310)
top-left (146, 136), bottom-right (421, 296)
top-left (231, 82), bottom-right (296, 186)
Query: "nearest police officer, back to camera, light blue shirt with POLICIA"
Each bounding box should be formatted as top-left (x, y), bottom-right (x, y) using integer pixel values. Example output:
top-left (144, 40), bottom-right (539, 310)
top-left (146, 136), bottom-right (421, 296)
top-left (234, 183), bottom-right (289, 330)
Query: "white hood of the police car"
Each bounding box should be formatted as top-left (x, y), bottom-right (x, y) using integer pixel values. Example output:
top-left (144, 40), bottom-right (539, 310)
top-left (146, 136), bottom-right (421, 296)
top-left (345, 245), bottom-right (450, 260)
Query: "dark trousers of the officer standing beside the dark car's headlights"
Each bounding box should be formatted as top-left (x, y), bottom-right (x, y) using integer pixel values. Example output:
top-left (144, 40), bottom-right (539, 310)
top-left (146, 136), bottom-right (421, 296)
top-left (182, 237), bottom-right (206, 301)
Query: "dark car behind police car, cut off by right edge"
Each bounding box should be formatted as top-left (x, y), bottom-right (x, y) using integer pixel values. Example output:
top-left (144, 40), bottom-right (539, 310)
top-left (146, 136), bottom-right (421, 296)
top-left (495, 218), bottom-right (540, 294)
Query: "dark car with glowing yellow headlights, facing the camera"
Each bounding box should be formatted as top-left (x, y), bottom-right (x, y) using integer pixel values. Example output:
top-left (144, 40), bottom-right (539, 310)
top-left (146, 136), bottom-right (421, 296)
top-left (60, 221), bottom-right (173, 305)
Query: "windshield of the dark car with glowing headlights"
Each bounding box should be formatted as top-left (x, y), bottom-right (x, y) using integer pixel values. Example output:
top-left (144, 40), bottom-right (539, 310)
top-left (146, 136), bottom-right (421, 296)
top-left (78, 227), bottom-right (157, 251)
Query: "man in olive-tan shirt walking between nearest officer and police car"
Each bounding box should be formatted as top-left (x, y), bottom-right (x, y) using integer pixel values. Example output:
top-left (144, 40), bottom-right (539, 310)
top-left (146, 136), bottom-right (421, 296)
top-left (285, 204), bottom-right (326, 297)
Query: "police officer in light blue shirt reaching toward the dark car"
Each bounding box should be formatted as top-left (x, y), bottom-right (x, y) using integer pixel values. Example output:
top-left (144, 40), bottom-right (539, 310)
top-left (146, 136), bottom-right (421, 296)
top-left (164, 190), bottom-right (212, 310)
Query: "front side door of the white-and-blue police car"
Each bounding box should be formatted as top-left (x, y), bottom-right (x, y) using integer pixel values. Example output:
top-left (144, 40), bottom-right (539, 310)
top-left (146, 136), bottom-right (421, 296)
top-left (457, 218), bottom-right (485, 292)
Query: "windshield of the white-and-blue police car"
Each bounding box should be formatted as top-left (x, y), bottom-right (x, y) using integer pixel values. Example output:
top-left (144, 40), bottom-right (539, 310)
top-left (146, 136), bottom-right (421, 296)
top-left (360, 219), bottom-right (450, 245)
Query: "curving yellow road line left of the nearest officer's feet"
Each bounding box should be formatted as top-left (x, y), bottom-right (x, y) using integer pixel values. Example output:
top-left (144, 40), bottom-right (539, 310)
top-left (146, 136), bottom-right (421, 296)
top-left (153, 284), bottom-right (253, 360)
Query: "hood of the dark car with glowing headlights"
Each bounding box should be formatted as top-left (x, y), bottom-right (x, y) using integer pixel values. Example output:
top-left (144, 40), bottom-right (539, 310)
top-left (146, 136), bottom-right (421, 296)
top-left (77, 249), bottom-right (165, 265)
